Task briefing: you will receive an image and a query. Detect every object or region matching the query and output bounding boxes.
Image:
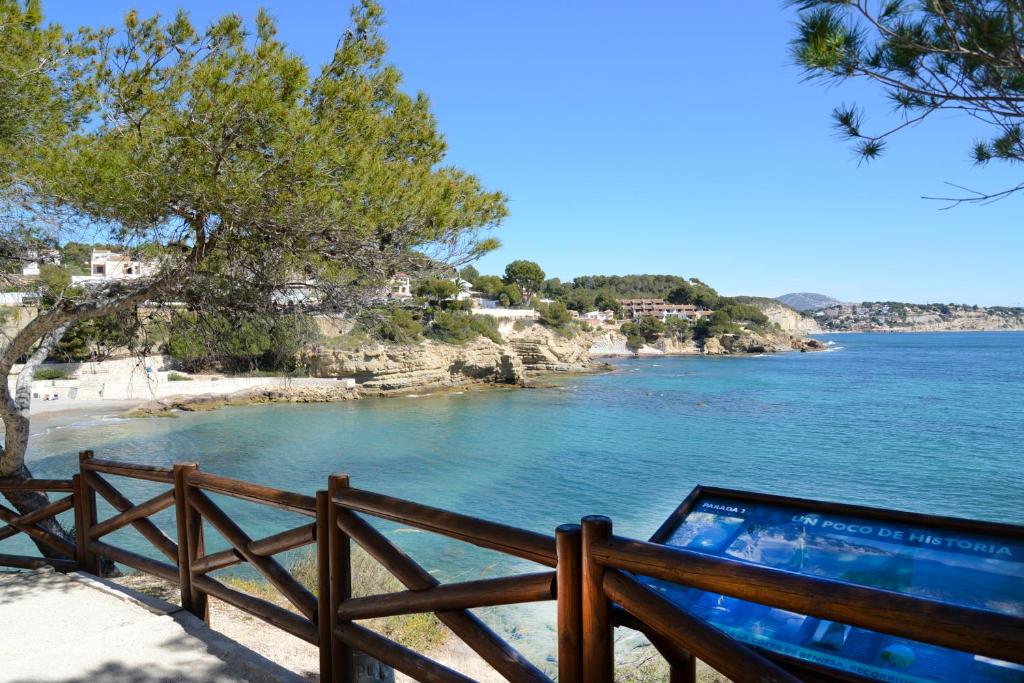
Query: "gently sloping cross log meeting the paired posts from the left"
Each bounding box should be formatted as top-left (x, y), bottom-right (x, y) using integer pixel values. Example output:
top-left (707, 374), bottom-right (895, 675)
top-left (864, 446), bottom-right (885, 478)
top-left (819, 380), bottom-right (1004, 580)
top-left (338, 571), bottom-right (555, 622)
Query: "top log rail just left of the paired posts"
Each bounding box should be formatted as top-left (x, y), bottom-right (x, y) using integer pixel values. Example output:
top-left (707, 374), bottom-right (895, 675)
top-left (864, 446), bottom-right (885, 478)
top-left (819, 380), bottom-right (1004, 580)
top-left (334, 488), bottom-right (558, 567)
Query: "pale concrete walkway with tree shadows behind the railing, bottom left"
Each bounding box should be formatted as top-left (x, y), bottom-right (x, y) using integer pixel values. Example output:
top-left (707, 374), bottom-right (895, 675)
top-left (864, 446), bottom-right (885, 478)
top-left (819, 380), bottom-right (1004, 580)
top-left (0, 569), bottom-right (305, 683)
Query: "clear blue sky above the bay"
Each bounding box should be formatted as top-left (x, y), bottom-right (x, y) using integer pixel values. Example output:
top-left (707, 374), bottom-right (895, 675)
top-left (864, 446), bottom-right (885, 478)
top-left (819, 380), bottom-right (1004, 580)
top-left (44, 0), bottom-right (1024, 305)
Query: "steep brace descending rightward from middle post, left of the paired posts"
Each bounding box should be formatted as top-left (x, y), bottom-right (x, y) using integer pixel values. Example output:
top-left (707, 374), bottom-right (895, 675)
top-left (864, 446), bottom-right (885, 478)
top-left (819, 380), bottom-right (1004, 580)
top-left (332, 507), bottom-right (551, 683)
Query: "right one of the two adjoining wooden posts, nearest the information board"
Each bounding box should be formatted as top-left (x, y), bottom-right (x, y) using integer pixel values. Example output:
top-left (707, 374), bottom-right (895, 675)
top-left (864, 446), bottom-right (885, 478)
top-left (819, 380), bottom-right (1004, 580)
top-left (581, 515), bottom-right (614, 683)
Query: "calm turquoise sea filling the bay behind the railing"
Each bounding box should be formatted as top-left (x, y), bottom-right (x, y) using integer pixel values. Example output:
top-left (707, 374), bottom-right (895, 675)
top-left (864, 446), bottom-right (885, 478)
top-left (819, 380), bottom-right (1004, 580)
top-left (9, 333), bottom-right (1024, 663)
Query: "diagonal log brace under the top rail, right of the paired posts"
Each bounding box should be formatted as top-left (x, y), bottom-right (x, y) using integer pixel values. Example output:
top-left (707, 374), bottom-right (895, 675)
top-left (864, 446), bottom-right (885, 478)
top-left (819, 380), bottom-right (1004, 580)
top-left (603, 569), bottom-right (800, 683)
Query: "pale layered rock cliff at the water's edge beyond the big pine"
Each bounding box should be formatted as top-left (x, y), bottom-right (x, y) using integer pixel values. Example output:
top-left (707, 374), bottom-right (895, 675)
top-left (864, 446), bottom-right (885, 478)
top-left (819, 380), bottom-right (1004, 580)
top-left (303, 324), bottom-right (591, 394)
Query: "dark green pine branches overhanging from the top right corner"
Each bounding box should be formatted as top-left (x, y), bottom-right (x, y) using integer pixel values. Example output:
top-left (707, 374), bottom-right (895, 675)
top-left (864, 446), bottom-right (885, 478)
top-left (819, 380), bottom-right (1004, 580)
top-left (793, 0), bottom-right (1024, 203)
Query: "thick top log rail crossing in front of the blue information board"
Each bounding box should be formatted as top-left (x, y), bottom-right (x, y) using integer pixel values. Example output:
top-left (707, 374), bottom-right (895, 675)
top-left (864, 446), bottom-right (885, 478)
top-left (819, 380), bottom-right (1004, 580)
top-left (592, 537), bottom-right (1024, 663)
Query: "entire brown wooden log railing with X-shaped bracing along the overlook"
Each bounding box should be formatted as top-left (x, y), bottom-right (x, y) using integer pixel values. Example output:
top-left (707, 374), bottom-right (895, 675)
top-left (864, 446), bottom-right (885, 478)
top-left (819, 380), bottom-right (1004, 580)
top-left (0, 452), bottom-right (1024, 683)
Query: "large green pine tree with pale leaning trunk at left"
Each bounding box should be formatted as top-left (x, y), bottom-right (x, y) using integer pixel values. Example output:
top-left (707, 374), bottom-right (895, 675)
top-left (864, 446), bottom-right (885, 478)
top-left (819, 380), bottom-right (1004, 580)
top-left (0, 0), bottom-right (506, 552)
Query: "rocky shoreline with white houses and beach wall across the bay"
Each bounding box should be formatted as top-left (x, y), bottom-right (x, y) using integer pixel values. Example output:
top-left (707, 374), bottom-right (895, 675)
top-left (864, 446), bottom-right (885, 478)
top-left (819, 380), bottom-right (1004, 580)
top-left (0, 247), bottom-right (823, 412)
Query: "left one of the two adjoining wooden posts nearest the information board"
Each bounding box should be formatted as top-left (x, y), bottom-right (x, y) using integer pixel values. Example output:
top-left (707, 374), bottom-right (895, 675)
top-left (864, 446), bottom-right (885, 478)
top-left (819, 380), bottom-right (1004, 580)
top-left (555, 524), bottom-right (584, 683)
